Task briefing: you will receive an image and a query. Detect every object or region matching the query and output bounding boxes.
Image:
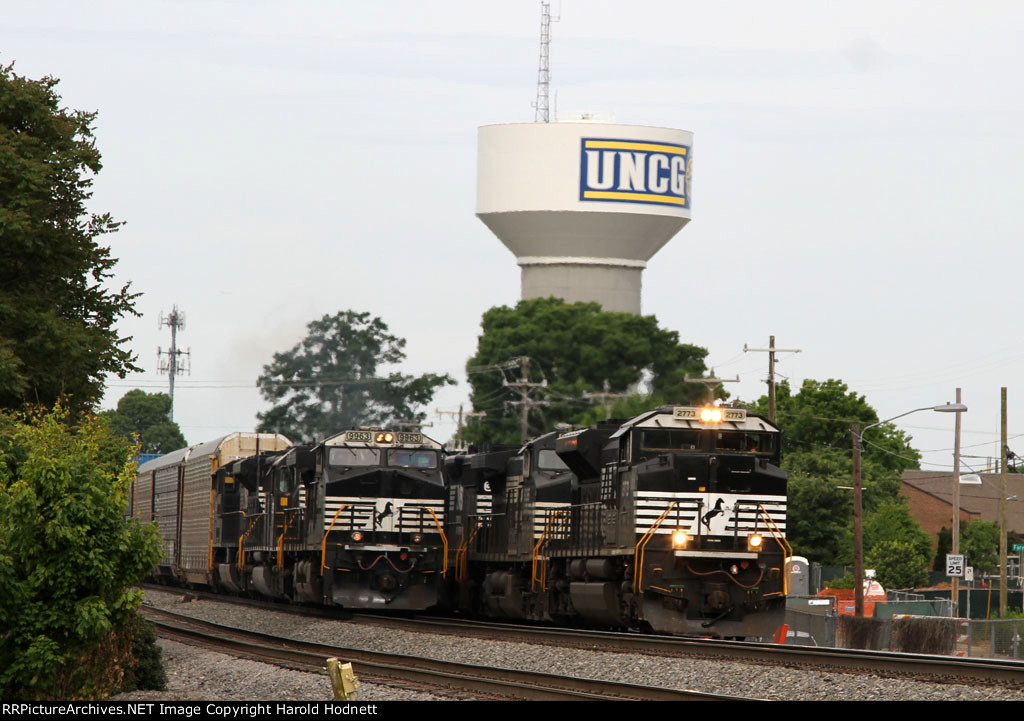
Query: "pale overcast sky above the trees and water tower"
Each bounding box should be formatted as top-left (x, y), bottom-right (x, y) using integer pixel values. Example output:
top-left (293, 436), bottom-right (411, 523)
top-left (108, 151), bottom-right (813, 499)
top-left (0, 0), bottom-right (1024, 471)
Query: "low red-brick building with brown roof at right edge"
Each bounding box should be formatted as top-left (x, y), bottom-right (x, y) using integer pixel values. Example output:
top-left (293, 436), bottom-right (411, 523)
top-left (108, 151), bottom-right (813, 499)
top-left (900, 471), bottom-right (1024, 548)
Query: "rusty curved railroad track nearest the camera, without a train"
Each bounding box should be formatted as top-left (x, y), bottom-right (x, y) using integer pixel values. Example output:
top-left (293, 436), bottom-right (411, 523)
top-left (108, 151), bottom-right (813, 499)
top-left (143, 606), bottom-right (754, 701)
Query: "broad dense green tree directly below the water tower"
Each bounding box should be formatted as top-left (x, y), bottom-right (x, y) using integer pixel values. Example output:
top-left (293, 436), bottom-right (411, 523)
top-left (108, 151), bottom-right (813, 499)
top-left (466, 298), bottom-right (708, 443)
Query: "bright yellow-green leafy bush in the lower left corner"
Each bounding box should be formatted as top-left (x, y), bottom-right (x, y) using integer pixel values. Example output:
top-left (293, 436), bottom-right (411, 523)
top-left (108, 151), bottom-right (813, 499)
top-left (0, 407), bottom-right (160, 699)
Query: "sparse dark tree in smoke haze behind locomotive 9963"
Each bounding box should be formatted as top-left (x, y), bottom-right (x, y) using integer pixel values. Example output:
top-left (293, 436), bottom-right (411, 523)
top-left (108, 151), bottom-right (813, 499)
top-left (257, 310), bottom-right (455, 440)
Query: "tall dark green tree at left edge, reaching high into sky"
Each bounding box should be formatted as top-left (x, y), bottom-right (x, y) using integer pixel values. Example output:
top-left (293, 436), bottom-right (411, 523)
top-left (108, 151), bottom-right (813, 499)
top-left (0, 66), bottom-right (140, 411)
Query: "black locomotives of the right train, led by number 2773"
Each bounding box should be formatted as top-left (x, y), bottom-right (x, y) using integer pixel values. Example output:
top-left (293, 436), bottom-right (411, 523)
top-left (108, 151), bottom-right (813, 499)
top-left (449, 407), bottom-right (790, 637)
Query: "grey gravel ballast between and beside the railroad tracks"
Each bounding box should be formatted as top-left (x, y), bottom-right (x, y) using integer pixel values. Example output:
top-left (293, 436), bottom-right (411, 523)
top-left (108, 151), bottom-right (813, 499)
top-left (130, 590), bottom-right (1024, 702)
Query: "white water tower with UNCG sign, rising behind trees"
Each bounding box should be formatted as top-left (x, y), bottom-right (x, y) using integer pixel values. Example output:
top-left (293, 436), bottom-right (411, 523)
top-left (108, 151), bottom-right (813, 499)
top-left (476, 122), bottom-right (693, 313)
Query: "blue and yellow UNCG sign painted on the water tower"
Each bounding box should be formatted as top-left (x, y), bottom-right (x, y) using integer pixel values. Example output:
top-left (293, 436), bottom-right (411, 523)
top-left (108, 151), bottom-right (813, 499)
top-left (580, 137), bottom-right (692, 208)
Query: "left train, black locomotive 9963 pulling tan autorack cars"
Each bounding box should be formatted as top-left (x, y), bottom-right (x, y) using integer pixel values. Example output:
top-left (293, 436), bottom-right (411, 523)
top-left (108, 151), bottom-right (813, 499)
top-left (131, 429), bottom-right (449, 610)
